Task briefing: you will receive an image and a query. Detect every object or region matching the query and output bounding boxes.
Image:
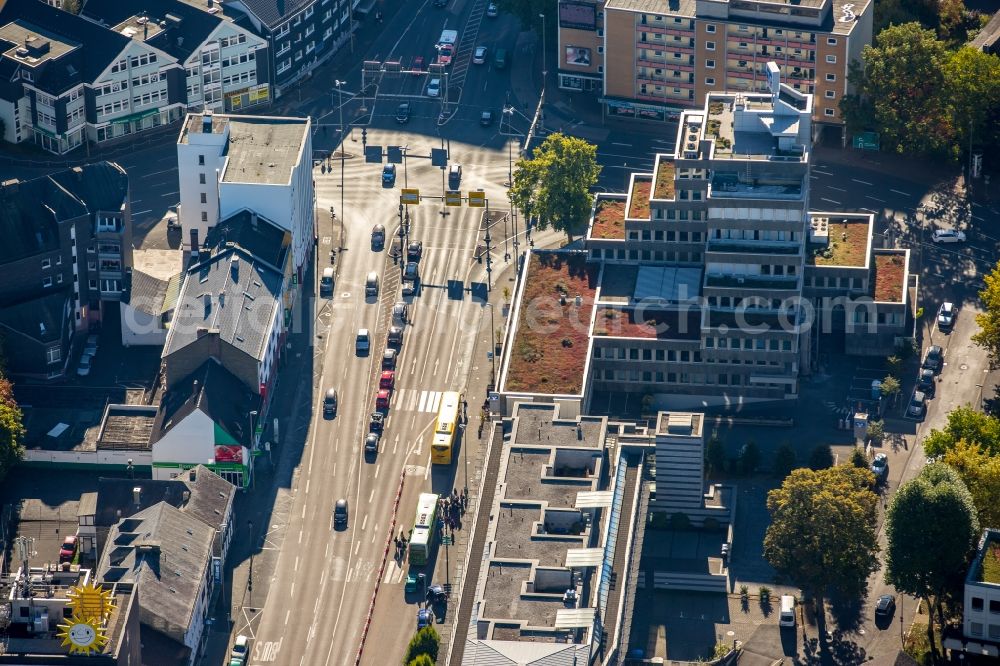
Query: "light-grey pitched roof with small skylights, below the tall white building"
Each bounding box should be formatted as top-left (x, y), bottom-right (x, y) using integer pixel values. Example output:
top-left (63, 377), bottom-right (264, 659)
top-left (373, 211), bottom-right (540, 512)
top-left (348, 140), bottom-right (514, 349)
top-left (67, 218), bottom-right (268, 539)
top-left (163, 241), bottom-right (283, 361)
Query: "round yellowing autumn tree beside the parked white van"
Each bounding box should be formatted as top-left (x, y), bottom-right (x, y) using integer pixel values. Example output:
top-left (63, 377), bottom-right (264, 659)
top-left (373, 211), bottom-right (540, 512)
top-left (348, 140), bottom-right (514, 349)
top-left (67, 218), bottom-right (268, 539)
top-left (764, 465), bottom-right (878, 650)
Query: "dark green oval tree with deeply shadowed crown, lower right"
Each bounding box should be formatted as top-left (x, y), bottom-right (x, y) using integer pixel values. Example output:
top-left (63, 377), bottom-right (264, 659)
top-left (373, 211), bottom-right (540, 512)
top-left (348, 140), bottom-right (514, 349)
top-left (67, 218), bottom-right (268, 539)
top-left (885, 463), bottom-right (979, 656)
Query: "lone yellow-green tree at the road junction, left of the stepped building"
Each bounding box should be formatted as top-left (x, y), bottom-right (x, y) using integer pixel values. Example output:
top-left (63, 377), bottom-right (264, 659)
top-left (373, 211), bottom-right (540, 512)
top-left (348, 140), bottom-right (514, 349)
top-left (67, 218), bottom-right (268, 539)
top-left (510, 132), bottom-right (601, 240)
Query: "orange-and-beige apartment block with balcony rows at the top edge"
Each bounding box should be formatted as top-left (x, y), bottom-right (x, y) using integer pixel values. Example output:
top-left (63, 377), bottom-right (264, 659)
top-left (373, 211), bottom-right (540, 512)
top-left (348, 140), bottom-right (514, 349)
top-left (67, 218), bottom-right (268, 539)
top-left (559, 0), bottom-right (874, 134)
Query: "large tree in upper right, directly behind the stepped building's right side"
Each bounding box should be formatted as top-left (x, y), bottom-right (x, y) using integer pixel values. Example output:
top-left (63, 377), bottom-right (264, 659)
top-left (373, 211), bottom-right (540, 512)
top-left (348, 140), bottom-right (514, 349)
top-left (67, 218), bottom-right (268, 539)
top-left (840, 23), bottom-right (957, 158)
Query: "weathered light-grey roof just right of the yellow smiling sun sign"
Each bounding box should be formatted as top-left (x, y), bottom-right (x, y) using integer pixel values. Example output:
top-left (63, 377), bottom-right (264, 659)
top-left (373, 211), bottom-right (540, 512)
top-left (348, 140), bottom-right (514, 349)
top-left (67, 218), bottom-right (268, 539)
top-left (97, 502), bottom-right (215, 642)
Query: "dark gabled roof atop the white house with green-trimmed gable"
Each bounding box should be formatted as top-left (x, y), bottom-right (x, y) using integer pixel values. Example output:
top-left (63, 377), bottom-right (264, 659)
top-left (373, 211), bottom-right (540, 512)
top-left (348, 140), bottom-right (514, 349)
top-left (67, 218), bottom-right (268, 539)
top-left (152, 359), bottom-right (260, 447)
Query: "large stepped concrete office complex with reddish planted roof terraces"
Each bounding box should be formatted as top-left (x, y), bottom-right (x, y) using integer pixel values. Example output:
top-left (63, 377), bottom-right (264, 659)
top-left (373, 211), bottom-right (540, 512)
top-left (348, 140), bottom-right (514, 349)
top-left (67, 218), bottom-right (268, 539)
top-left (500, 63), bottom-right (916, 414)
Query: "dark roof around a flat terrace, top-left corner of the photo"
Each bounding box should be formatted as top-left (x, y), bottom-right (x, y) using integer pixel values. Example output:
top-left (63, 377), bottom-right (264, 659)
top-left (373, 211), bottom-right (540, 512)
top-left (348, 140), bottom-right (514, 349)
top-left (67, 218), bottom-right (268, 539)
top-left (0, 0), bottom-right (129, 94)
